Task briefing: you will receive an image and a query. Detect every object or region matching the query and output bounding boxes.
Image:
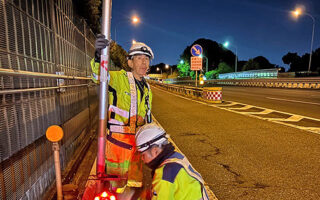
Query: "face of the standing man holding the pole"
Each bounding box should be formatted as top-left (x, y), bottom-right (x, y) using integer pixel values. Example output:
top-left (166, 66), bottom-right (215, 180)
top-left (128, 55), bottom-right (150, 80)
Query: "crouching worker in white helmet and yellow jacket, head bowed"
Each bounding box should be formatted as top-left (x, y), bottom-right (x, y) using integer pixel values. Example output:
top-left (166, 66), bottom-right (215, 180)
top-left (136, 123), bottom-right (209, 200)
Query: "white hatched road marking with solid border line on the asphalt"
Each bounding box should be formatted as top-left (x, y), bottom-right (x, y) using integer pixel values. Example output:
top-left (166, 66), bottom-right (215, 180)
top-left (154, 87), bottom-right (320, 134)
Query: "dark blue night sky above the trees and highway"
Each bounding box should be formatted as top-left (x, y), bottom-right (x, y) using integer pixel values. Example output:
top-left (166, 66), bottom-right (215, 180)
top-left (111, 0), bottom-right (320, 67)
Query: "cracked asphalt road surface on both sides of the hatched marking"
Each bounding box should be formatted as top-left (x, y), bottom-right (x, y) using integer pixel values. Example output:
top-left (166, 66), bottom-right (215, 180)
top-left (152, 87), bottom-right (320, 200)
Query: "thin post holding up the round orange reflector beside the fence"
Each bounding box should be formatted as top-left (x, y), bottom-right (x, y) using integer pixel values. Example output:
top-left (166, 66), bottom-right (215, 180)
top-left (52, 142), bottom-right (63, 200)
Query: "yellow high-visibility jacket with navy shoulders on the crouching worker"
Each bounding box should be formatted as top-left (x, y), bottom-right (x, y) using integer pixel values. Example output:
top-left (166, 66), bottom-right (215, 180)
top-left (152, 152), bottom-right (209, 200)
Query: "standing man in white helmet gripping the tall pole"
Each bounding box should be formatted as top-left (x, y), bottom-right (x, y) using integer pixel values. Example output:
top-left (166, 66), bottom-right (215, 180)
top-left (91, 35), bottom-right (154, 189)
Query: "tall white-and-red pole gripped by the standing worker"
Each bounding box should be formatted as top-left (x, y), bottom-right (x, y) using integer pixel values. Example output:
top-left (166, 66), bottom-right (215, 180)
top-left (97, 0), bottom-right (112, 192)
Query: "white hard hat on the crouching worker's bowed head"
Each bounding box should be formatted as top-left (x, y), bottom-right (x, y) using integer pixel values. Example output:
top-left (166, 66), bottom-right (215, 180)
top-left (136, 122), bottom-right (169, 152)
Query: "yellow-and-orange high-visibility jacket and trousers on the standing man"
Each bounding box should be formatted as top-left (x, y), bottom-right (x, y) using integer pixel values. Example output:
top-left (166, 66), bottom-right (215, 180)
top-left (91, 59), bottom-right (152, 187)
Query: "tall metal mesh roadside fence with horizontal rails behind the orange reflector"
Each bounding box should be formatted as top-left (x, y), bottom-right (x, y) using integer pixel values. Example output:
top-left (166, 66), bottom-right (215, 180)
top-left (0, 0), bottom-right (98, 200)
